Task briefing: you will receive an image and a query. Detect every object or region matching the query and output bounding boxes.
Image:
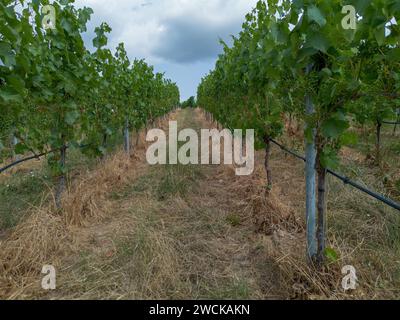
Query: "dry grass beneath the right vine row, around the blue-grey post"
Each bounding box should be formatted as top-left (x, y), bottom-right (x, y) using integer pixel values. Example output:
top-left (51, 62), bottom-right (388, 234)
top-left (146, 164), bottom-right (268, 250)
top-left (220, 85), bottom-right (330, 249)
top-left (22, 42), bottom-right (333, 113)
top-left (200, 108), bottom-right (400, 299)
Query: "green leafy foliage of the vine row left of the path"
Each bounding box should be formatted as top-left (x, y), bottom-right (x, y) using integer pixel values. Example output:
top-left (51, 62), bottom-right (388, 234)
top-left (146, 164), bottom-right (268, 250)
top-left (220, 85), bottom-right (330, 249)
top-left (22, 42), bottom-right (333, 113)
top-left (0, 0), bottom-right (179, 170)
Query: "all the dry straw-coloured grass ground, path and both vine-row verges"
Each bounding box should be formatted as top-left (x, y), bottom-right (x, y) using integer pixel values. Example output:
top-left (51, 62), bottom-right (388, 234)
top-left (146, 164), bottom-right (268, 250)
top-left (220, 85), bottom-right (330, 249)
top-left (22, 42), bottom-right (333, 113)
top-left (0, 109), bottom-right (400, 299)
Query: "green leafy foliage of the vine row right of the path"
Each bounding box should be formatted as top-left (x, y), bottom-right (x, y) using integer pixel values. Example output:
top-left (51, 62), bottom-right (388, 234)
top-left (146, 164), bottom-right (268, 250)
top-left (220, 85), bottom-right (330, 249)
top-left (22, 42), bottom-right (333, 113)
top-left (198, 0), bottom-right (400, 166)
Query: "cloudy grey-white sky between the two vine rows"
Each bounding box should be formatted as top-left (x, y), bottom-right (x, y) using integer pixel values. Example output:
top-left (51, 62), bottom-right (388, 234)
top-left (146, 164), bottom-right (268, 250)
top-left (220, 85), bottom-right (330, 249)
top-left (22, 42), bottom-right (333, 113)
top-left (76, 0), bottom-right (257, 100)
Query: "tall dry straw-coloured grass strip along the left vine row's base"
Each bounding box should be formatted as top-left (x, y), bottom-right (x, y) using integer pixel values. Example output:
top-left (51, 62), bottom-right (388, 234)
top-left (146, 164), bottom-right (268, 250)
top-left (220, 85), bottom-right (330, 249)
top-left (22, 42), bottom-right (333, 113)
top-left (0, 113), bottom-right (175, 299)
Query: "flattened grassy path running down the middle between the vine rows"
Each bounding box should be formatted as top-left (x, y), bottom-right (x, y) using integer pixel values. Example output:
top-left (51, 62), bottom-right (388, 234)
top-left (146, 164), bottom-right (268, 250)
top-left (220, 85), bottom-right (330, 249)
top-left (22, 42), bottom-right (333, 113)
top-left (39, 110), bottom-right (282, 299)
